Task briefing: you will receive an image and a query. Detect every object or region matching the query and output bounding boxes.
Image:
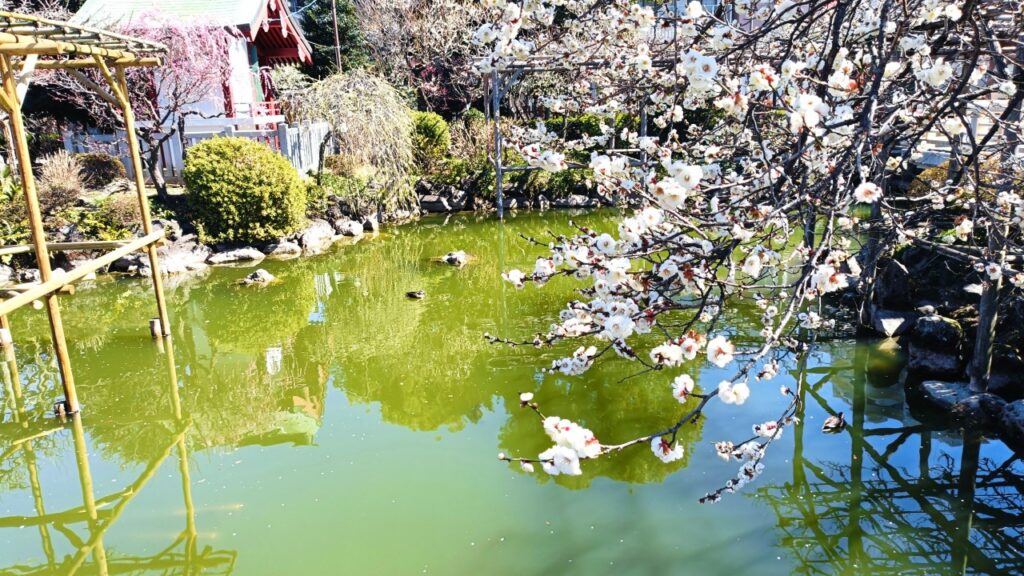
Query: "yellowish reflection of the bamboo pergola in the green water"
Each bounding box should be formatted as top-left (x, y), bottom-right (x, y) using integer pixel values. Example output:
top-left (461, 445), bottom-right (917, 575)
top-left (0, 334), bottom-right (238, 576)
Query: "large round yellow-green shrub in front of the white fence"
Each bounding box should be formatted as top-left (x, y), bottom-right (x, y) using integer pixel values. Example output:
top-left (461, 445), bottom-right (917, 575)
top-left (182, 137), bottom-right (306, 242)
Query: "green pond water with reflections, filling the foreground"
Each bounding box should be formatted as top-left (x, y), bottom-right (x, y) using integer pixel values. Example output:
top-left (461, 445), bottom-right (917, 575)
top-left (0, 212), bottom-right (1024, 575)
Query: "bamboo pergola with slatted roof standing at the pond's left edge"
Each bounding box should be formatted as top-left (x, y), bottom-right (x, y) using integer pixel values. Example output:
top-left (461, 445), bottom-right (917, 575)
top-left (0, 11), bottom-right (170, 414)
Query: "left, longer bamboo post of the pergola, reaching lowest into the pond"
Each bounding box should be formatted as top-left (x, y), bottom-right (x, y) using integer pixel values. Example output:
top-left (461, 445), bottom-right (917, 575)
top-left (0, 54), bottom-right (79, 414)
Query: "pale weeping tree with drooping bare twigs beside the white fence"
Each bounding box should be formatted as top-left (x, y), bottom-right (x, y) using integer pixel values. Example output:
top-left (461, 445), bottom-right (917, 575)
top-left (273, 70), bottom-right (414, 205)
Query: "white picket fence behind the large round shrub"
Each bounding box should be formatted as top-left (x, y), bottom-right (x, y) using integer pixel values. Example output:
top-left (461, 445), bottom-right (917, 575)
top-left (63, 116), bottom-right (330, 182)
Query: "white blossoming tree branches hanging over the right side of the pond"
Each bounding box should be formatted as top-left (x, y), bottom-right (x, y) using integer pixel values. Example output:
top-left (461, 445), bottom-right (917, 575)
top-left (481, 0), bottom-right (1024, 497)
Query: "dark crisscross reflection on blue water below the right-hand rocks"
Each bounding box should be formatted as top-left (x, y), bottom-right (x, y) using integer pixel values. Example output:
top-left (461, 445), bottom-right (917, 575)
top-left (759, 342), bottom-right (1024, 575)
